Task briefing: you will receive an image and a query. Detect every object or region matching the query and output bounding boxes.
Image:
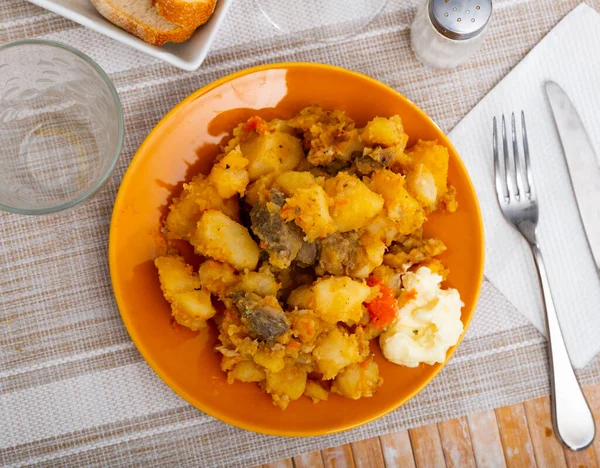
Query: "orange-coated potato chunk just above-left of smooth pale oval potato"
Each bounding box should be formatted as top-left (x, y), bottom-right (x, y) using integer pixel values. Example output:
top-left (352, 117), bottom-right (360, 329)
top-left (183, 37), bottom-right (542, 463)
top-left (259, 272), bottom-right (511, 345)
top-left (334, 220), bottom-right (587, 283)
top-left (165, 174), bottom-right (239, 240)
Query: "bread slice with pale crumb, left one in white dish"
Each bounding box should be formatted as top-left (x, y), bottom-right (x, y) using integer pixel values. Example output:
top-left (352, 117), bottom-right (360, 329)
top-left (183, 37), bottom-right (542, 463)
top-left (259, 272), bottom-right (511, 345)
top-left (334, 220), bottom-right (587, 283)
top-left (91, 0), bottom-right (194, 45)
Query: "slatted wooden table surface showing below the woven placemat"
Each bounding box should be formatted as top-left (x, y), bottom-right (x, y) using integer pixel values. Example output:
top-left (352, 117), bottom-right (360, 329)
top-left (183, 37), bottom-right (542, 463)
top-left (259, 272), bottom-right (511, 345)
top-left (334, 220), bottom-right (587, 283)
top-left (263, 384), bottom-right (600, 468)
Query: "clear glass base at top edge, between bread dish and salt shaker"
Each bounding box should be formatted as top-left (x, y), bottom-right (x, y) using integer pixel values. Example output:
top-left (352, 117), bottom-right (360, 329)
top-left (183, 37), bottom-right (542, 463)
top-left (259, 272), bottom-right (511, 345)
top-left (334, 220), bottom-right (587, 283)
top-left (256, 0), bottom-right (388, 42)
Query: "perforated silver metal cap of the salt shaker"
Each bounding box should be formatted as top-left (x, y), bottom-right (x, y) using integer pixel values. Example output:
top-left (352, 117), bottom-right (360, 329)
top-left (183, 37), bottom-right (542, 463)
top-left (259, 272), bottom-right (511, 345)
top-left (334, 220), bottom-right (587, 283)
top-left (429, 0), bottom-right (492, 41)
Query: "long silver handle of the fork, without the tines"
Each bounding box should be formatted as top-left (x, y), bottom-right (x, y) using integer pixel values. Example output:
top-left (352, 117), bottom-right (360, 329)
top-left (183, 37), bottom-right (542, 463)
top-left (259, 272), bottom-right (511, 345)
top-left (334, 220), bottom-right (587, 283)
top-left (531, 243), bottom-right (596, 450)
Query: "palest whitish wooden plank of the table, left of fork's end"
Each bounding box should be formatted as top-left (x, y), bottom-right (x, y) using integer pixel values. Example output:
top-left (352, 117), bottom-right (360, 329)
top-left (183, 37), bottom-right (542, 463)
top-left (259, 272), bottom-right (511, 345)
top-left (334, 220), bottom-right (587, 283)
top-left (467, 410), bottom-right (506, 468)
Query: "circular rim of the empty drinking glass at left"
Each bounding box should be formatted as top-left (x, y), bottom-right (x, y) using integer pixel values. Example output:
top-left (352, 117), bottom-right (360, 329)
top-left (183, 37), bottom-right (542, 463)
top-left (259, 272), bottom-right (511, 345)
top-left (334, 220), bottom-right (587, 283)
top-left (0, 39), bottom-right (125, 215)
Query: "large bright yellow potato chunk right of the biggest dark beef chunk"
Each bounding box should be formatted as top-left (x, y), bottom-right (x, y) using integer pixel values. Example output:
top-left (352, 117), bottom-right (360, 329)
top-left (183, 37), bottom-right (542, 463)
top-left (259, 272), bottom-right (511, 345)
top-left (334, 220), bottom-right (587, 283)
top-left (325, 172), bottom-right (383, 232)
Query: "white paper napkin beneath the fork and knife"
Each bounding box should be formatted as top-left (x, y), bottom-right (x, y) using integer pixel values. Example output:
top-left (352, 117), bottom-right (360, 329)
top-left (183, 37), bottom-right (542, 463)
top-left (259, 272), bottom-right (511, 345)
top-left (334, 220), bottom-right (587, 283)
top-left (450, 4), bottom-right (600, 368)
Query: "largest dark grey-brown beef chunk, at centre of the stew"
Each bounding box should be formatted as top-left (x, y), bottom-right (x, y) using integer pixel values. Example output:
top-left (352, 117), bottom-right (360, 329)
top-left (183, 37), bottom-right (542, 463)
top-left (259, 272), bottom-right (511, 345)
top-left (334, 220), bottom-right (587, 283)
top-left (250, 189), bottom-right (304, 268)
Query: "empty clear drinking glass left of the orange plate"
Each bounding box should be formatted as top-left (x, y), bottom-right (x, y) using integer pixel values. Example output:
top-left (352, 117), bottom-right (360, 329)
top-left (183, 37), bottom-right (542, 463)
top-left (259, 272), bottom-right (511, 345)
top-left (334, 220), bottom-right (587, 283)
top-left (0, 40), bottom-right (124, 214)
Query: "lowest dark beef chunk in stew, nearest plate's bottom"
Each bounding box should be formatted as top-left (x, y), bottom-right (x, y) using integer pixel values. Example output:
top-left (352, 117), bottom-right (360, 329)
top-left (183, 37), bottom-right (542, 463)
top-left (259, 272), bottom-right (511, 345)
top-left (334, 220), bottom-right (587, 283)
top-left (231, 292), bottom-right (290, 341)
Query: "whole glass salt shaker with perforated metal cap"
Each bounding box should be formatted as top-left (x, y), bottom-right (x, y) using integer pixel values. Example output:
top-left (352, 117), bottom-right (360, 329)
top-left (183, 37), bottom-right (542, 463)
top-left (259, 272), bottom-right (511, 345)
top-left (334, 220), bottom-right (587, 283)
top-left (410, 0), bottom-right (492, 68)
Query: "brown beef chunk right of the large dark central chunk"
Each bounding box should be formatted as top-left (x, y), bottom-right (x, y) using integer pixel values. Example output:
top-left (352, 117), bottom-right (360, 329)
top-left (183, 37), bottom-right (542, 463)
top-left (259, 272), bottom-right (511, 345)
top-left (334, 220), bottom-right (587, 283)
top-left (319, 231), bottom-right (359, 276)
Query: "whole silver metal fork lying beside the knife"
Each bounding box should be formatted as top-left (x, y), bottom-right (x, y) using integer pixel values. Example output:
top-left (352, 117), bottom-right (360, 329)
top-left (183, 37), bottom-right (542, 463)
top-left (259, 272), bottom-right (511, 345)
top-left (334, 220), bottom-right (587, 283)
top-left (493, 111), bottom-right (595, 450)
